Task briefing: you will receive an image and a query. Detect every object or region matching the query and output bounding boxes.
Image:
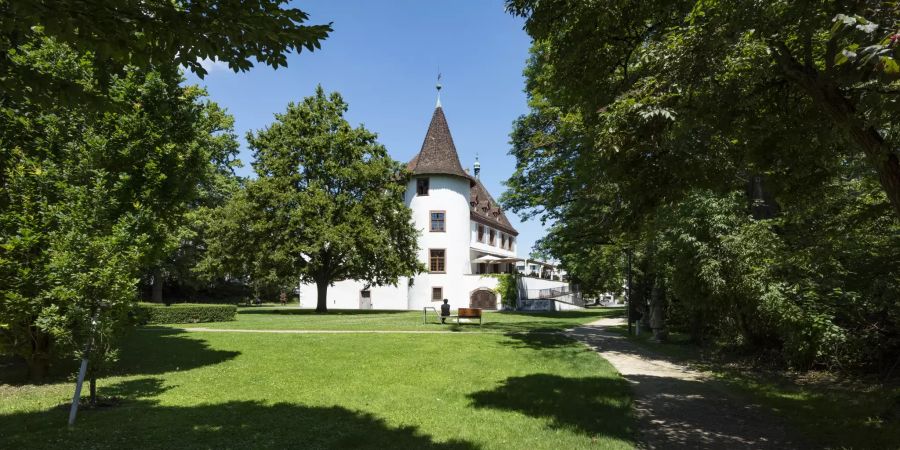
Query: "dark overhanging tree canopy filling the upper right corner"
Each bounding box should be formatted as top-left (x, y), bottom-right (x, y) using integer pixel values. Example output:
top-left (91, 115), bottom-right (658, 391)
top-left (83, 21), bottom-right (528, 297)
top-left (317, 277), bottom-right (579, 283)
top-left (507, 0), bottom-right (900, 216)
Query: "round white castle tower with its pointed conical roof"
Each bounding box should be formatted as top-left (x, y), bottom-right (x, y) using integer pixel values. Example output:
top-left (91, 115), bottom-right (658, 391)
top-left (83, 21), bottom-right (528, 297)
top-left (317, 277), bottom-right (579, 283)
top-left (406, 98), bottom-right (473, 309)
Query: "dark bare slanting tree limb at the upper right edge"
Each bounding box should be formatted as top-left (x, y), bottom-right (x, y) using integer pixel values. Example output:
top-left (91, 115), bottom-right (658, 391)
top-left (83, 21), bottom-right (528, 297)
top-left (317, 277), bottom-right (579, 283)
top-left (770, 43), bottom-right (900, 216)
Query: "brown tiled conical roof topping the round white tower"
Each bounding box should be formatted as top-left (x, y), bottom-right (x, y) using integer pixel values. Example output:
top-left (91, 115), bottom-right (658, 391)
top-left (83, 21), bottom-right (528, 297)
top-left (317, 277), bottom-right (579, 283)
top-left (407, 103), bottom-right (471, 179)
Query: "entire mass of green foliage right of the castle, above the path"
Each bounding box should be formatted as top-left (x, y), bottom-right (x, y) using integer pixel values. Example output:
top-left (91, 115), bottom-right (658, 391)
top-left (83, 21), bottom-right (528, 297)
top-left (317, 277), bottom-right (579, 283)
top-left (503, 0), bottom-right (900, 372)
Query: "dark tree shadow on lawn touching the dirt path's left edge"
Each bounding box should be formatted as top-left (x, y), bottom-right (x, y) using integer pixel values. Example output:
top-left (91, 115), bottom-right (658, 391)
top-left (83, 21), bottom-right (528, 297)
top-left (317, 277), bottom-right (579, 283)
top-left (468, 374), bottom-right (634, 441)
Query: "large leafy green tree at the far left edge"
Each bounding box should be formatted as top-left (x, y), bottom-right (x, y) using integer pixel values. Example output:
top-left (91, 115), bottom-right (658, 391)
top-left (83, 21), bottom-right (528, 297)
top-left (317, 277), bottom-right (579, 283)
top-left (0, 38), bottom-right (239, 380)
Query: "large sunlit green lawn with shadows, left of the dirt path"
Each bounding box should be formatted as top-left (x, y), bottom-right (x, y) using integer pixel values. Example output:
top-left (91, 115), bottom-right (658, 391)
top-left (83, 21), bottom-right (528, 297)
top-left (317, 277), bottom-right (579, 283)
top-left (0, 310), bottom-right (634, 449)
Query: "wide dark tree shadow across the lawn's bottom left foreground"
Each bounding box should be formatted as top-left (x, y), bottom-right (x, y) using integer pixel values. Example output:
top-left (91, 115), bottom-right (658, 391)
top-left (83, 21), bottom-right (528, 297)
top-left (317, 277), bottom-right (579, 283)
top-left (0, 378), bottom-right (478, 450)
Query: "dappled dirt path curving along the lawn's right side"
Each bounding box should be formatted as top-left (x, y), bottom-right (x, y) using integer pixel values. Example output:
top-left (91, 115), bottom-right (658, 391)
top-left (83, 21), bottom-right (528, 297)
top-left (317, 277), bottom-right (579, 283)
top-left (568, 319), bottom-right (802, 449)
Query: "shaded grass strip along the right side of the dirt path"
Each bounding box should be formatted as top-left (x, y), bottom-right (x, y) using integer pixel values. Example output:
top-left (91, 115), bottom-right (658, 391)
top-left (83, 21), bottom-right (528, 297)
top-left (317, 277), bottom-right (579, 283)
top-left (610, 325), bottom-right (900, 449)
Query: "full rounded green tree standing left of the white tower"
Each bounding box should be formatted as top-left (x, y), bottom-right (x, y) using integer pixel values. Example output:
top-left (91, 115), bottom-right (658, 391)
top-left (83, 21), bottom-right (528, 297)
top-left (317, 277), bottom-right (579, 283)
top-left (209, 86), bottom-right (423, 312)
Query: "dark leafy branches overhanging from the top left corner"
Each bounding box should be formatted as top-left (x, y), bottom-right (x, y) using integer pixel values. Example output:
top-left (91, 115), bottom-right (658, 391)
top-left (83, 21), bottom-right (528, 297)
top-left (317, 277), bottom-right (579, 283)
top-left (0, 0), bottom-right (331, 106)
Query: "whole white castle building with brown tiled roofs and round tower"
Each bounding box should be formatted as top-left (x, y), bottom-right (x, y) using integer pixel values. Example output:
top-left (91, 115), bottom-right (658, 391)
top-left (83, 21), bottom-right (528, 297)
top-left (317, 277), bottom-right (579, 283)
top-left (300, 100), bottom-right (565, 309)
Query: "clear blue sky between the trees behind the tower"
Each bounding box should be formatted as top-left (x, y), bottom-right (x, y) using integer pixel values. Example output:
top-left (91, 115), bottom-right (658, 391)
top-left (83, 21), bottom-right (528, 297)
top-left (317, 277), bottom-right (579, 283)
top-left (188, 0), bottom-right (543, 257)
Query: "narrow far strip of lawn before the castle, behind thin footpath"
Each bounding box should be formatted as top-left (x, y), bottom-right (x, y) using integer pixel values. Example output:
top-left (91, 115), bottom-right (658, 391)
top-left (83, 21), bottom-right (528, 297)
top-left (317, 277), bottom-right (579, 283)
top-left (165, 306), bottom-right (618, 332)
